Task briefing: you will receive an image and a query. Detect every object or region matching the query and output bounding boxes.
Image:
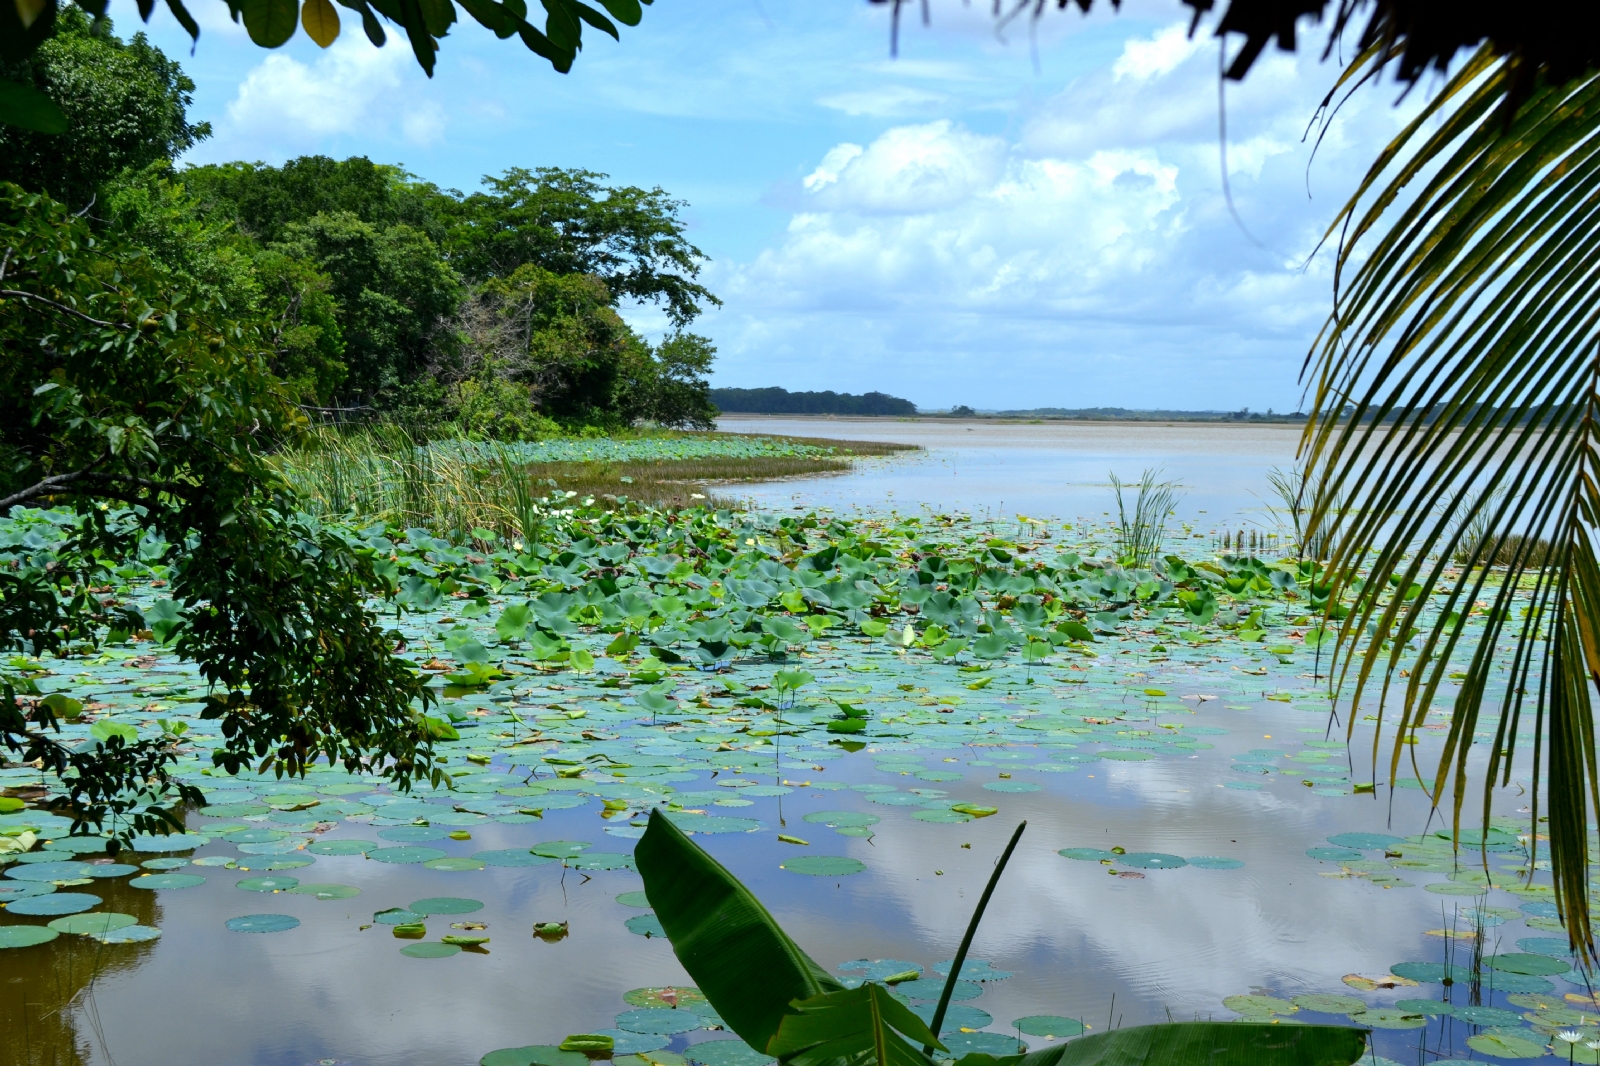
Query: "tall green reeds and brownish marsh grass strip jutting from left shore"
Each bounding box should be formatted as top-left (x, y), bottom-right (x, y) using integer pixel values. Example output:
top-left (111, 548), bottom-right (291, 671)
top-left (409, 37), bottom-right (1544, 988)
top-left (275, 424), bottom-right (907, 541)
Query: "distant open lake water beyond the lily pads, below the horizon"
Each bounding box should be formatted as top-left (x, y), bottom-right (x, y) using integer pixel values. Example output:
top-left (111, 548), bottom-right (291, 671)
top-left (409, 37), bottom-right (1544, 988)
top-left (718, 416), bottom-right (1301, 530)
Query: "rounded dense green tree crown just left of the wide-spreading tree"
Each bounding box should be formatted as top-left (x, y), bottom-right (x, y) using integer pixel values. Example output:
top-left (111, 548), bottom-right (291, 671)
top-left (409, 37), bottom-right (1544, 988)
top-left (272, 211), bottom-right (461, 405)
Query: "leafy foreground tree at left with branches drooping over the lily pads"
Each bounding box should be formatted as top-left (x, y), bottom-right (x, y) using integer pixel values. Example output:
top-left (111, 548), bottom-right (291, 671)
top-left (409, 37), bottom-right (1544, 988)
top-left (0, 184), bottom-right (440, 832)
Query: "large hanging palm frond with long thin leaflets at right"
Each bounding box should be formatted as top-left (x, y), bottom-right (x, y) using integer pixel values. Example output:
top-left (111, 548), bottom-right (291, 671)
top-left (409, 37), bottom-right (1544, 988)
top-left (1302, 46), bottom-right (1600, 964)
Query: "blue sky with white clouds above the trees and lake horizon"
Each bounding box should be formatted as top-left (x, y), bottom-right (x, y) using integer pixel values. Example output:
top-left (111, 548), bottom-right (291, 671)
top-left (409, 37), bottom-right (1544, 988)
top-left (110, 0), bottom-right (1411, 411)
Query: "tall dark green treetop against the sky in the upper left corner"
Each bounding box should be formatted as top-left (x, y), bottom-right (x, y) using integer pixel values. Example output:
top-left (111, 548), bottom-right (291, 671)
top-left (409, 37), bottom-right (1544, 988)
top-left (0, 8), bottom-right (211, 206)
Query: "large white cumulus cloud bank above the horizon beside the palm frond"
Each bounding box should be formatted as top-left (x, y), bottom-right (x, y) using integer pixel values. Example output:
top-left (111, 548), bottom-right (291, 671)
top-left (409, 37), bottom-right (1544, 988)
top-left (714, 24), bottom-right (1403, 408)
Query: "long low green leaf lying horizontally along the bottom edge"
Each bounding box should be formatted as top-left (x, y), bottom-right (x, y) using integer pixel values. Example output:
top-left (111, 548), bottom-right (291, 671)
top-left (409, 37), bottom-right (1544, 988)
top-left (957, 1021), bottom-right (1366, 1066)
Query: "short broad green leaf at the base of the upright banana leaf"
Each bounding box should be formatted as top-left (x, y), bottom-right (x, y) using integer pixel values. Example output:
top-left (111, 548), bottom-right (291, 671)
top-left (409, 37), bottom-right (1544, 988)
top-left (766, 981), bottom-right (946, 1066)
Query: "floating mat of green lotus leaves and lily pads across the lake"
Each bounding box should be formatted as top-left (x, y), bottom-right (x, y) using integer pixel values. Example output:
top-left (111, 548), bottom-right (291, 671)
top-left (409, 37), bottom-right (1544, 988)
top-left (0, 499), bottom-right (1568, 1066)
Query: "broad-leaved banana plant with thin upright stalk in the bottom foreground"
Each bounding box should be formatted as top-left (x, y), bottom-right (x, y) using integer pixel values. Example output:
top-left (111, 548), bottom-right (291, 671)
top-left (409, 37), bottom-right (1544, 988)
top-left (634, 810), bottom-right (1366, 1066)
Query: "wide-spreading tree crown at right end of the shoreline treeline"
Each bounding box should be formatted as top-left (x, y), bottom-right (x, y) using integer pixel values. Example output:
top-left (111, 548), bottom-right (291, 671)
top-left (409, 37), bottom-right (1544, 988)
top-left (446, 166), bottom-right (722, 327)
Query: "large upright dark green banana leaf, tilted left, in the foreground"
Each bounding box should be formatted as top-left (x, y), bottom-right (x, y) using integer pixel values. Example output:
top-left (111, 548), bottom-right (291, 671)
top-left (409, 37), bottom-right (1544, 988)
top-left (634, 807), bottom-right (843, 1048)
